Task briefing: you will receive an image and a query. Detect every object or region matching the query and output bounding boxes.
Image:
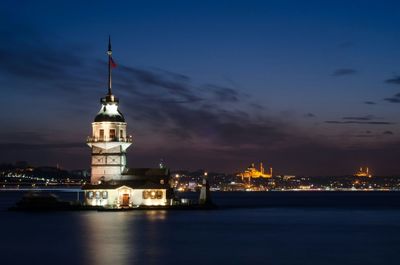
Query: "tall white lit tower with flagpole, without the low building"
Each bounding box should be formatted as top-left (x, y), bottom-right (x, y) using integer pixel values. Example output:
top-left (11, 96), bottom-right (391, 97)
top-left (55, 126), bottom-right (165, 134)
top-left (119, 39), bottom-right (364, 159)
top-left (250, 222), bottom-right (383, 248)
top-left (87, 37), bottom-right (132, 184)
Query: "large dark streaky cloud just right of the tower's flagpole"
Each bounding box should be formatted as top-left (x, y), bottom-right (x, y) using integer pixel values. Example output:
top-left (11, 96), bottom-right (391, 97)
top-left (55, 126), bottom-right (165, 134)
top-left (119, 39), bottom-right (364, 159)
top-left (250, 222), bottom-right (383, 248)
top-left (110, 62), bottom-right (287, 148)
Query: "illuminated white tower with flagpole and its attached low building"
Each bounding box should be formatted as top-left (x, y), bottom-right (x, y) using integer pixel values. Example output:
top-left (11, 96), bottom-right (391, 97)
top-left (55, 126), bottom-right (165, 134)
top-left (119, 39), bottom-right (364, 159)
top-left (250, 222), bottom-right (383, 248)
top-left (82, 38), bottom-right (174, 208)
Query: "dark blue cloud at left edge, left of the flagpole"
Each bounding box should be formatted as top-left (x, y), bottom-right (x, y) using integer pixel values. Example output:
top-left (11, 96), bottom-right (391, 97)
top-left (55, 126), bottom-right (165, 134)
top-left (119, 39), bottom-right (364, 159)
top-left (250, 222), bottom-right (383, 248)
top-left (0, 20), bottom-right (103, 101)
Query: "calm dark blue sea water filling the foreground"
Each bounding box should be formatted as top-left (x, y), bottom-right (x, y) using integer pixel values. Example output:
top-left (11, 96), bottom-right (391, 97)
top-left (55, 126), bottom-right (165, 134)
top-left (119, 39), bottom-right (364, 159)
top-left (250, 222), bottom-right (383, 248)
top-left (0, 194), bottom-right (400, 265)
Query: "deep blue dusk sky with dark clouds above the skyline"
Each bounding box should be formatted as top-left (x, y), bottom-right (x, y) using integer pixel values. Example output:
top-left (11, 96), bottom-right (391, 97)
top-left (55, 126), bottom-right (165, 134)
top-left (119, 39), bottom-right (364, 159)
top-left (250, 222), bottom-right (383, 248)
top-left (0, 0), bottom-right (400, 175)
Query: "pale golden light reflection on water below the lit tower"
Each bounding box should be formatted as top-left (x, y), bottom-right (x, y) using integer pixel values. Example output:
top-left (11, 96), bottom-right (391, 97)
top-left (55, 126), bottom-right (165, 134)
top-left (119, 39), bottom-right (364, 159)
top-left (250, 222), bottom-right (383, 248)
top-left (82, 210), bottom-right (167, 265)
